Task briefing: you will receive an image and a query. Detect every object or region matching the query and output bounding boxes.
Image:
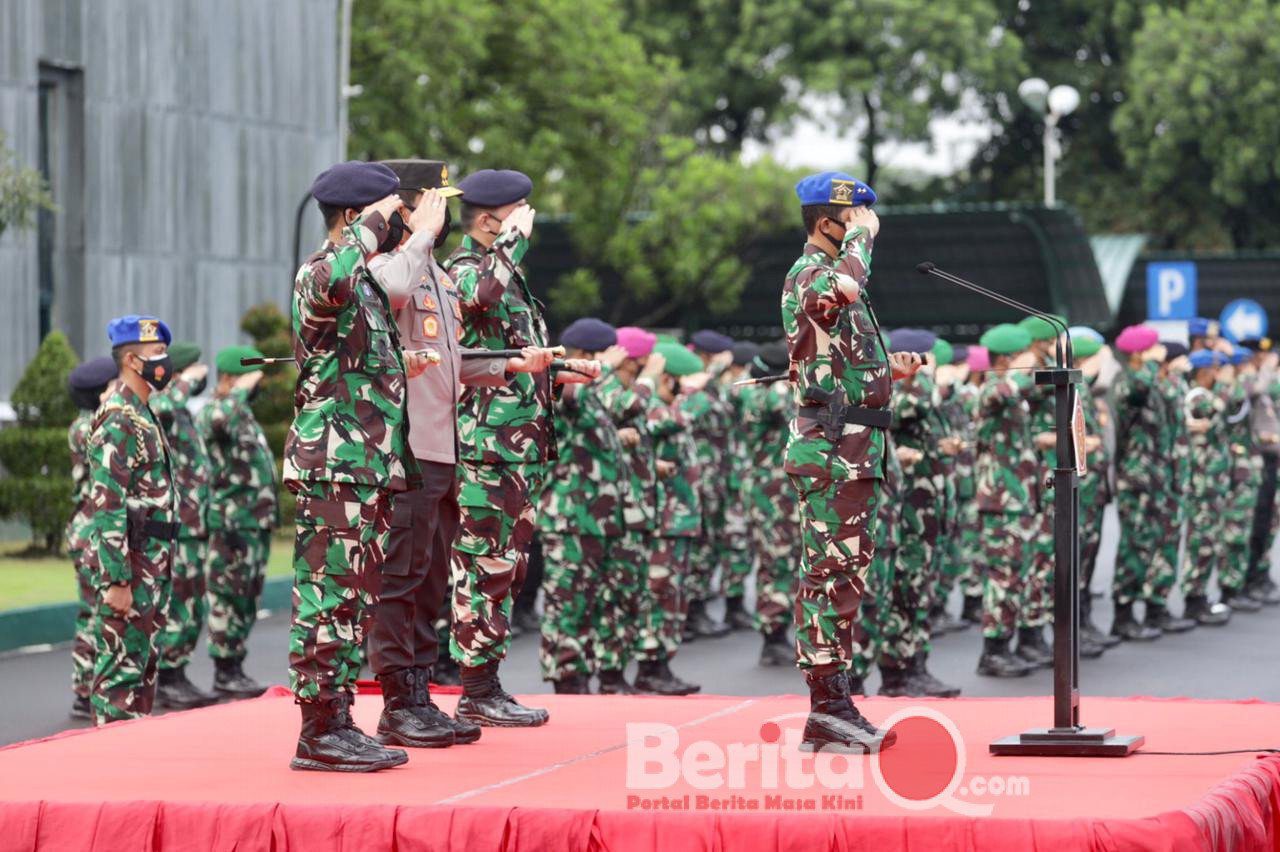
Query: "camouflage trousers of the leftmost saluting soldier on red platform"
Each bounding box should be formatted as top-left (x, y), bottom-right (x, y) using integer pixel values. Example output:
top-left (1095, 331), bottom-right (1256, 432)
top-left (289, 482), bottom-right (390, 704)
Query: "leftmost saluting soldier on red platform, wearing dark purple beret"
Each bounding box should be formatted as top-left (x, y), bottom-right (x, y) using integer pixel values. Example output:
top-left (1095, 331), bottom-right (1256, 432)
top-left (284, 161), bottom-right (426, 771)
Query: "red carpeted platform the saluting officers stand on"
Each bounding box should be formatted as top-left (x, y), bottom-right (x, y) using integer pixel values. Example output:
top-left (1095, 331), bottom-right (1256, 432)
top-left (0, 688), bottom-right (1280, 852)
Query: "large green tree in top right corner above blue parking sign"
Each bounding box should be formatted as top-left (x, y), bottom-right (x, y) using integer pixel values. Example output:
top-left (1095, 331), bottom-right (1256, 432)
top-left (1114, 0), bottom-right (1280, 248)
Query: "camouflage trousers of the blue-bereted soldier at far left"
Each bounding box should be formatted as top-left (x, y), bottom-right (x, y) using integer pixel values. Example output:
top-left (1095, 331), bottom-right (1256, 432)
top-left (90, 539), bottom-right (173, 725)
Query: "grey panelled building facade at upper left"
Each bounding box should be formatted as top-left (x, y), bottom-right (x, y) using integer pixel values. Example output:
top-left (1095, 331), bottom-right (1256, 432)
top-left (0, 0), bottom-right (339, 399)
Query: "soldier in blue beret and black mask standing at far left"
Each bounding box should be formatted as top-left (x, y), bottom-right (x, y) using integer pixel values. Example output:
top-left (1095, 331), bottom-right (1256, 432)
top-left (84, 315), bottom-right (178, 725)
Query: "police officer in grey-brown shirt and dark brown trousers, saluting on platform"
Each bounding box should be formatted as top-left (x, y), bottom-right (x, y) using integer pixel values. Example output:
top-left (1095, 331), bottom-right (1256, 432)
top-left (369, 160), bottom-right (552, 748)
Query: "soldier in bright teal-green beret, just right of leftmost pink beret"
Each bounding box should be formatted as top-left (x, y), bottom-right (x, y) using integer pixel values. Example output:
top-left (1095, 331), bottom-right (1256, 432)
top-left (635, 340), bottom-right (708, 695)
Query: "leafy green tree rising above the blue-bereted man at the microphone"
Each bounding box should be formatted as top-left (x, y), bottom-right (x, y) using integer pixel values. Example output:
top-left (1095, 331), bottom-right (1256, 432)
top-left (796, 0), bottom-right (1023, 185)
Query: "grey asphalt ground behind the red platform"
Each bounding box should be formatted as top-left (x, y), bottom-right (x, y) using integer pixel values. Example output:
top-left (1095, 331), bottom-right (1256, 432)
top-left (0, 504), bottom-right (1280, 743)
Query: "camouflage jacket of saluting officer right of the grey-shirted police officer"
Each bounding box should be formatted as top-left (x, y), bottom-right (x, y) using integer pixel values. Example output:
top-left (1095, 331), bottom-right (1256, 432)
top-left (444, 234), bottom-right (557, 464)
